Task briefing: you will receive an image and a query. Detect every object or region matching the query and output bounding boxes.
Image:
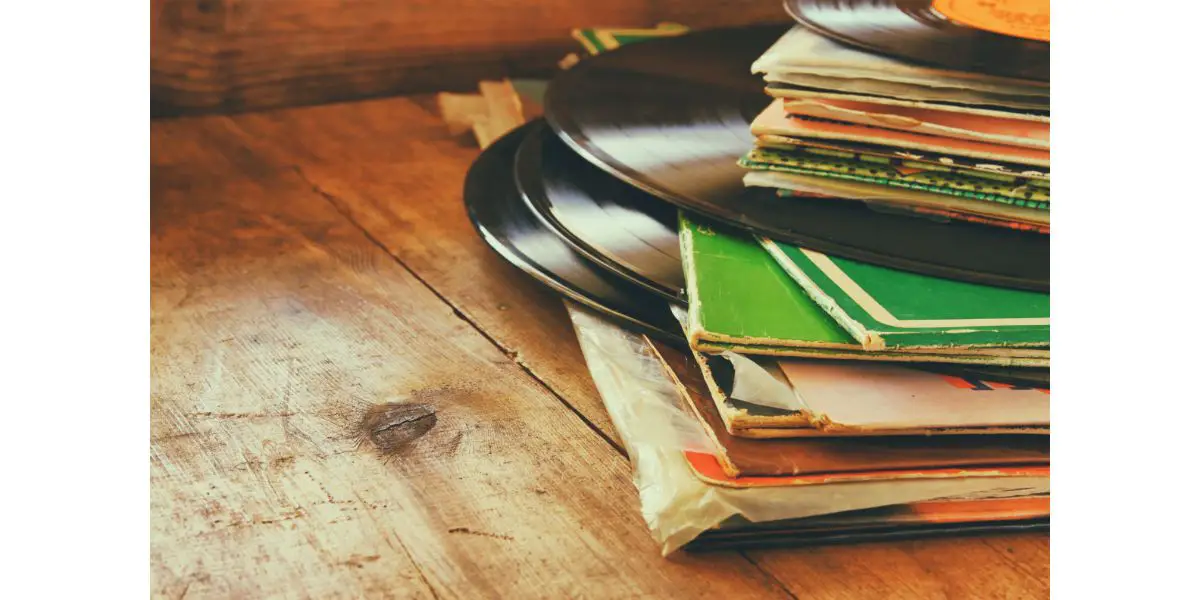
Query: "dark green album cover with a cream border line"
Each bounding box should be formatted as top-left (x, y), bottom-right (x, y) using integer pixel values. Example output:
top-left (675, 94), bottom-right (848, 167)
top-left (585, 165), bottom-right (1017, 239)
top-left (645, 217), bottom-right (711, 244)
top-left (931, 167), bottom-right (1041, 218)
top-left (761, 240), bottom-right (1050, 350)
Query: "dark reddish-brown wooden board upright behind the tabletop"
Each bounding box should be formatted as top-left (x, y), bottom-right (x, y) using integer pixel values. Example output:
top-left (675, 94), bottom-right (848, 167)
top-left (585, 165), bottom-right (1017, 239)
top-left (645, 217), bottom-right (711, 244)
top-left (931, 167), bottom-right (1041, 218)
top-left (150, 0), bottom-right (788, 116)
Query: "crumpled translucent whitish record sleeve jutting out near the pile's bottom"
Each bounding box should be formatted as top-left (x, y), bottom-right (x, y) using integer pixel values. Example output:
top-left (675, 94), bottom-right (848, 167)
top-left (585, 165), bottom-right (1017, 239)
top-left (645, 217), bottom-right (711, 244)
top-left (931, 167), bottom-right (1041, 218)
top-left (568, 302), bottom-right (1050, 554)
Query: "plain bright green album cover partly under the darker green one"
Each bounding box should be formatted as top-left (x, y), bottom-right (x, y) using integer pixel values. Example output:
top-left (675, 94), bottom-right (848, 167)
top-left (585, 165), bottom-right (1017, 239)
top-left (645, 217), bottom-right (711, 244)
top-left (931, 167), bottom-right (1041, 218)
top-left (679, 214), bottom-right (1049, 366)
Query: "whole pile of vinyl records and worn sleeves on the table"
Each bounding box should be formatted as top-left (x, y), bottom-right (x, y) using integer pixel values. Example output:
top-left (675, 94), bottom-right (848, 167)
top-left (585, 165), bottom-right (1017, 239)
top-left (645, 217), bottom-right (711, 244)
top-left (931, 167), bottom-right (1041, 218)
top-left (464, 0), bottom-right (1050, 552)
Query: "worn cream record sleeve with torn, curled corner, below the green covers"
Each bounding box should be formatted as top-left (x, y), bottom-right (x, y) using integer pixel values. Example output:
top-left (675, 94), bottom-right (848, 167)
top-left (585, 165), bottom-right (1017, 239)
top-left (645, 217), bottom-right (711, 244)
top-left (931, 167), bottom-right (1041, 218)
top-left (692, 350), bottom-right (1050, 438)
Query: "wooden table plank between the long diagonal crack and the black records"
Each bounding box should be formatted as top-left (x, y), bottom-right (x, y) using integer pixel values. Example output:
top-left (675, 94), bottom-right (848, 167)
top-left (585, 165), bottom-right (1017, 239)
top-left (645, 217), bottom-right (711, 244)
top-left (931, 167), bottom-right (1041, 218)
top-left (212, 98), bottom-right (617, 440)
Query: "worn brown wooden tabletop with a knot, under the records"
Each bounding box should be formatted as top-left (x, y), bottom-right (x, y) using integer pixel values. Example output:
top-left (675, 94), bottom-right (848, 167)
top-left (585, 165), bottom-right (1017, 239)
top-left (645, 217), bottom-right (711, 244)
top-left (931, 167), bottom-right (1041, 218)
top-left (150, 98), bottom-right (1050, 598)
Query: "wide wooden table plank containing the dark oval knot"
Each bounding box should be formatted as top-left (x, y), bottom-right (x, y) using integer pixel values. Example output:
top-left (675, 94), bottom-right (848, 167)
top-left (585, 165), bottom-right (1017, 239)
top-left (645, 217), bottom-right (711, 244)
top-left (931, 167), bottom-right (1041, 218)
top-left (150, 118), bottom-right (786, 598)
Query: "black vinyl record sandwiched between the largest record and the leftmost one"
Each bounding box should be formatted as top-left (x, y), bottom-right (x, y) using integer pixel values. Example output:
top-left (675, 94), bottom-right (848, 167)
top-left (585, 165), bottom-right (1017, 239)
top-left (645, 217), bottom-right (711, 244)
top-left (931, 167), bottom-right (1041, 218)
top-left (516, 121), bottom-right (685, 302)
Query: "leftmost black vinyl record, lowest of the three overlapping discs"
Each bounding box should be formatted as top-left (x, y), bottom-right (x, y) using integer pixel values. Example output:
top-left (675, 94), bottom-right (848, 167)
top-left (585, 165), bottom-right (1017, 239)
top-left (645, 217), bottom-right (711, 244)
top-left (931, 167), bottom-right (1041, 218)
top-left (463, 120), bottom-right (683, 343)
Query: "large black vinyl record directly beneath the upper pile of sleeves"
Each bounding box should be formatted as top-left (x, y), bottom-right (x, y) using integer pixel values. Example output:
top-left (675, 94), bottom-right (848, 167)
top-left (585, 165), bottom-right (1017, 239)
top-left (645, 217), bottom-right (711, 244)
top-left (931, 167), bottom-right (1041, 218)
top-left (545, 26), bottom-right (1050, 290)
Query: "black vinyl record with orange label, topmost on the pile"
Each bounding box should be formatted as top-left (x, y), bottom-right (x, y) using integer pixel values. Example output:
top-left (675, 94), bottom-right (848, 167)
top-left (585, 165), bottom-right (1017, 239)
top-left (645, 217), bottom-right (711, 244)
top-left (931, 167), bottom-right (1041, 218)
top-left (785, 0), bottom-right (1050, 82)
